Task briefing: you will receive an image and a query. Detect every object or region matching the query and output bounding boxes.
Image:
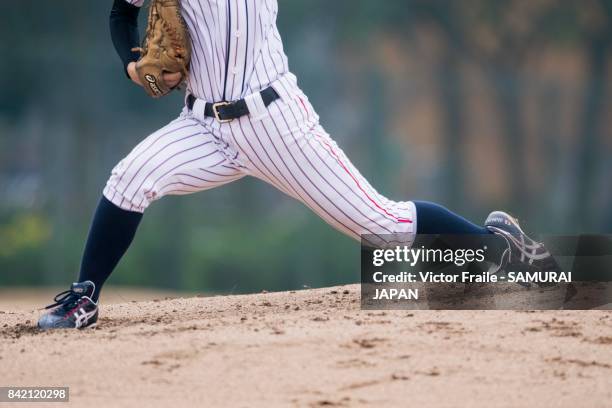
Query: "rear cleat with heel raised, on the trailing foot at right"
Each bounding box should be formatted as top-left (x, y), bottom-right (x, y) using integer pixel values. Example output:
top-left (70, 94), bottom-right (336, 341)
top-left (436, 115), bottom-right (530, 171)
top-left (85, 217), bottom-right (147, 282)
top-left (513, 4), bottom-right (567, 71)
top-left (485, 211), bottom-right (560, 280)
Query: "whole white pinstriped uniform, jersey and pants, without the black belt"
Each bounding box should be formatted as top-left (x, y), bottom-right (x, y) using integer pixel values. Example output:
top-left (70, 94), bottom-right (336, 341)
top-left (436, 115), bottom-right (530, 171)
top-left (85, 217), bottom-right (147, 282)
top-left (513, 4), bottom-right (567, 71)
top-left (113, 0), bottom-right (416, 245)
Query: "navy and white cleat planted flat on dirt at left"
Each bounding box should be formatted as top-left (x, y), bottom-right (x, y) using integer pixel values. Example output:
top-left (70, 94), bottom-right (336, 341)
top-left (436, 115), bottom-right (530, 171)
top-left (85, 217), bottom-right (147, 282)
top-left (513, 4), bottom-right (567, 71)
top-left (38, 281), bottom-right (98, 330)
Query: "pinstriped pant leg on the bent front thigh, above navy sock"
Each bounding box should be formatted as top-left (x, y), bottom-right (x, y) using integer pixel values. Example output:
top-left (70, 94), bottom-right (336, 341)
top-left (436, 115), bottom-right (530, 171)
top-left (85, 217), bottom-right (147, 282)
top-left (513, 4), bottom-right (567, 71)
top-left (104, 115), bottom-right (245, 212)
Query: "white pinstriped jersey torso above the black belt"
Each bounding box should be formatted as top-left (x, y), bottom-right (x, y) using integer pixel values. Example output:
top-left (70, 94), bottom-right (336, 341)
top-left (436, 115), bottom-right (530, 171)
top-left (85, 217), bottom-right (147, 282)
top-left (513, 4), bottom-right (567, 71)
top-left (127, 0), bottom-right (289, 102)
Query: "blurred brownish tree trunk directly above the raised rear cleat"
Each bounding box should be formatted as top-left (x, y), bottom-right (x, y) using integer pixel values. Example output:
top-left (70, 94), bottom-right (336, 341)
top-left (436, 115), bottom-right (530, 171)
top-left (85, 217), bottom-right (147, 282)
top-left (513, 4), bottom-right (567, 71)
top-left (458, 0), bottom-right (564, 219)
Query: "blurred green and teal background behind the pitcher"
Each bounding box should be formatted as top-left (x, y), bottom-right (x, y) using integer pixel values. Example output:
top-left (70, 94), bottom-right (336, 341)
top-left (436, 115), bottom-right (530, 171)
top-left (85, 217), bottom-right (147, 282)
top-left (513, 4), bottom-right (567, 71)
top-left (0, 0), bottom-right (612, 293)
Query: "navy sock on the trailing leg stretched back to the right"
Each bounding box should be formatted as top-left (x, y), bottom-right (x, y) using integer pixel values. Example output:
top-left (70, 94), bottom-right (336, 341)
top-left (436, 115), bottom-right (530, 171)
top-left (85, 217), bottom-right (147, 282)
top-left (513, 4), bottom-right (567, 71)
top-left (413, 201), bottom-right (508, 262)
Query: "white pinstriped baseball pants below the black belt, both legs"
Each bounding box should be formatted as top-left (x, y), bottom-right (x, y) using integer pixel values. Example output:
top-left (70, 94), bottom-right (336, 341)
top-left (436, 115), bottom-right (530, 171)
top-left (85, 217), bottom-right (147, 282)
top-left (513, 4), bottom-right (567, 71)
top-left (104, 77), bottom-right (416, 245)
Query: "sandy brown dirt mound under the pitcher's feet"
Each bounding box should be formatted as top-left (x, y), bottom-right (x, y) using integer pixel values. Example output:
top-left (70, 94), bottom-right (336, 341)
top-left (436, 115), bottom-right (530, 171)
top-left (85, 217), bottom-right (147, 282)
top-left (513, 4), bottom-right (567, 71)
top-left (0, 285), bottom-right (612, 408)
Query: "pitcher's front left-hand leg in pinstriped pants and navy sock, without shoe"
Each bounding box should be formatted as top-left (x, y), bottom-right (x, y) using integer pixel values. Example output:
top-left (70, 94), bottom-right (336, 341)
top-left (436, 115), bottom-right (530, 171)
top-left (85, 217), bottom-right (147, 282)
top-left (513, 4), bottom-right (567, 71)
top-left (86, 116), bottom-right (244, 300)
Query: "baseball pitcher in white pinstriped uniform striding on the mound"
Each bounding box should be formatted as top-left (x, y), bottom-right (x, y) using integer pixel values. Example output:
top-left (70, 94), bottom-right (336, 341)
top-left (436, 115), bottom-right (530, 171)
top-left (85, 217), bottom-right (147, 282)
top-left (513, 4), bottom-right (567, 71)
top-left (38, 0), bottom-right (550, 329)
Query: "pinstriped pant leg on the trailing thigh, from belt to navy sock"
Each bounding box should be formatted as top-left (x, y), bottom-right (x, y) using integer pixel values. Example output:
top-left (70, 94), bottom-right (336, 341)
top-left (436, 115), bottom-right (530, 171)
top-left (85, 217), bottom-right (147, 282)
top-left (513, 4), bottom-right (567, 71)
top-left (234, 94), bottom-right (416, 244)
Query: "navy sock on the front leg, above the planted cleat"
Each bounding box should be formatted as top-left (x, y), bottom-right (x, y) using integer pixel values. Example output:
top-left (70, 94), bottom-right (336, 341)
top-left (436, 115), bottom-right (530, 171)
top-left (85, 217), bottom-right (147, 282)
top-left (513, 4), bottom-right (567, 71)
top-left (79, 197), bottom-right (142, 302)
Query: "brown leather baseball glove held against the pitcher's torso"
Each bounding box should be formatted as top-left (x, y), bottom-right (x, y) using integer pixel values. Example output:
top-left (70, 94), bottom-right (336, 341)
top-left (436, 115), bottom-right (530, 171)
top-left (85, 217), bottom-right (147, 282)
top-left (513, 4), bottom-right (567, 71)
top-left (133, 0), bottom-right (191, 98)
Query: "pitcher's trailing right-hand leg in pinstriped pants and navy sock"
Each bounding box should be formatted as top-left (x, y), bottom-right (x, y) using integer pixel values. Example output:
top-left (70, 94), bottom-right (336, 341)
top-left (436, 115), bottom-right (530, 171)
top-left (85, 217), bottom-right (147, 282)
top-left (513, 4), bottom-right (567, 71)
top-left (246, 92), bottom-right (506, 259)
